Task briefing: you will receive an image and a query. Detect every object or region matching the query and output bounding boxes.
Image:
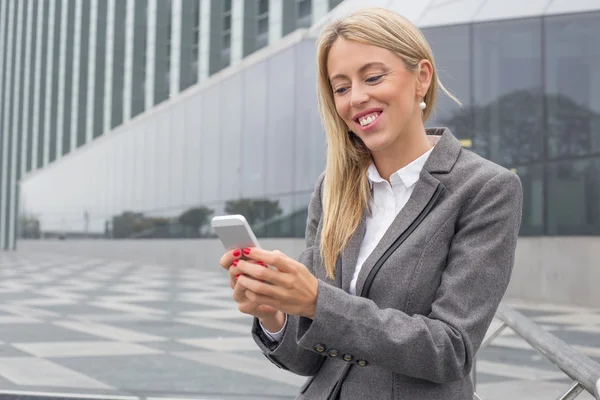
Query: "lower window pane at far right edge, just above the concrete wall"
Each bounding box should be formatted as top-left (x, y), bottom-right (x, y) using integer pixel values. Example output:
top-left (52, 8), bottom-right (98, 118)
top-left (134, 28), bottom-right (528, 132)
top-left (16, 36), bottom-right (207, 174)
top-left (548, 158), bottom-right (600, 235)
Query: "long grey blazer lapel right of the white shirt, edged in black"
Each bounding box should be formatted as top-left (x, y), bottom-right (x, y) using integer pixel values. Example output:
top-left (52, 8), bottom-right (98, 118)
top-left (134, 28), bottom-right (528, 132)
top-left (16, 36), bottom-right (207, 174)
top-left (352, 171), bottom-right (440, 295)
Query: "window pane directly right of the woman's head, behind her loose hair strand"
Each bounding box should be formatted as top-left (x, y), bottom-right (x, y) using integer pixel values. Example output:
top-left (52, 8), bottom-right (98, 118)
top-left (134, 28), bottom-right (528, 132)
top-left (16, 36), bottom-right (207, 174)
top-left (424, 25), bottom-right (473, 145)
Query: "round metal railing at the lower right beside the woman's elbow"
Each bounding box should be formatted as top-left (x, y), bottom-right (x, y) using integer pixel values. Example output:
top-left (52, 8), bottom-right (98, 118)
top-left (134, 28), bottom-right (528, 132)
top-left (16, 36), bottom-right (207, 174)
top-left (471, 304), bottom-right (600, 400)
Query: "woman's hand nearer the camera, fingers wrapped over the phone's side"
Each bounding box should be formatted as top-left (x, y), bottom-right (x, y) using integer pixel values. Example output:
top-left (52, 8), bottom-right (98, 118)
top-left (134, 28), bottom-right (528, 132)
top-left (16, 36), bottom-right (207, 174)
top-left (237, 247), bottom-right (319, 319)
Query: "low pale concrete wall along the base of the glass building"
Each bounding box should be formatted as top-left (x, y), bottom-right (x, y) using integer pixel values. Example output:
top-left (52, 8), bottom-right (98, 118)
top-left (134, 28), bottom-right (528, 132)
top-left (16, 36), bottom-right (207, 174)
top-left (18, 237), bottom-right (600, 308)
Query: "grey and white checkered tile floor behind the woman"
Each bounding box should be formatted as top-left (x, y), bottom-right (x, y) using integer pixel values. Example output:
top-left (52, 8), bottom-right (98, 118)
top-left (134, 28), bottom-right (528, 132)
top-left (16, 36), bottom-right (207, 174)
top-left (0, 252), bottom-right (600, 400)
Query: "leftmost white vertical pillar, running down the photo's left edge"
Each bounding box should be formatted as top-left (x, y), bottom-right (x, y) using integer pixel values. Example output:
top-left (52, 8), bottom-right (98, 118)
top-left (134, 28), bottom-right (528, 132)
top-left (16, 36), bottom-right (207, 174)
top-left (0, 0), bottom-right (16, 249)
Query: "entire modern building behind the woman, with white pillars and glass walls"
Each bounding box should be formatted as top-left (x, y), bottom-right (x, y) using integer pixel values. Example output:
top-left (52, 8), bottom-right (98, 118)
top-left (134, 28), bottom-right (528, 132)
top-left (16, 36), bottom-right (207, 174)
top-left (0, 0), bottom-right (600, 249)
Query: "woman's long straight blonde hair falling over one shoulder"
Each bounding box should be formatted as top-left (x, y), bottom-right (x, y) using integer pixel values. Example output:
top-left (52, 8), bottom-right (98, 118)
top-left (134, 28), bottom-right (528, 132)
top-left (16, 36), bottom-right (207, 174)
top-left (317, 8), bottom-right (458, 279)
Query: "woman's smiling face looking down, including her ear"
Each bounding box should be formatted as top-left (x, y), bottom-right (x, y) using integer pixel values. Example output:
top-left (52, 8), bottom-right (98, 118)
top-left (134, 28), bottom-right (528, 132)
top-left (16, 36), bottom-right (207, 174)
top-left (327, 37), bottom-right (431, 153)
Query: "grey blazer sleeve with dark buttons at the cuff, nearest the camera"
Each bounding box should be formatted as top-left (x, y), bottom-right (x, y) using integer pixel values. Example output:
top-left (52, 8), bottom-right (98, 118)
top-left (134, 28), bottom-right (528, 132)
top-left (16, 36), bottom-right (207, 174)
top-left (298, 171), bottom-right (522, 383)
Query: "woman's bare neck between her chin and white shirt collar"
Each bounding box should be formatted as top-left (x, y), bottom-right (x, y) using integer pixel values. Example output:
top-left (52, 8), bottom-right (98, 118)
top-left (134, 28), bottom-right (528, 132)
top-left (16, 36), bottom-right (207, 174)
top-left (372, 127), bottom-right (433, 182)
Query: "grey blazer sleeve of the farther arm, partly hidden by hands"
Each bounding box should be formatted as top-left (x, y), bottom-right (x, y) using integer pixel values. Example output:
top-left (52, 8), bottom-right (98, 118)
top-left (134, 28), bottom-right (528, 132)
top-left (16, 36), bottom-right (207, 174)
top-left (252, 173), bottom-right (325, 376)
